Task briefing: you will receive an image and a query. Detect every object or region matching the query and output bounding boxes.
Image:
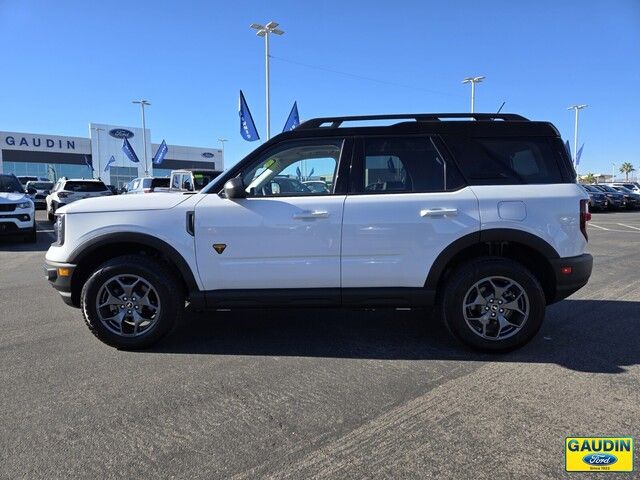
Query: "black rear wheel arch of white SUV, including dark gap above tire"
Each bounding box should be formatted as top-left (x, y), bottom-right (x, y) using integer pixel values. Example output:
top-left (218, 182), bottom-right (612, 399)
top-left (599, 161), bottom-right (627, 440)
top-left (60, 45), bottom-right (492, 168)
top-left (425, 228), bottom-right (560, 303)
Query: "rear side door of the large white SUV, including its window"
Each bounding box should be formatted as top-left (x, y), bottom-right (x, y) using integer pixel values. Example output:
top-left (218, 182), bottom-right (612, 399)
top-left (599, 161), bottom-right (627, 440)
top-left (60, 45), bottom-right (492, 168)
top-left (342, 136), bottom-right (480, 288)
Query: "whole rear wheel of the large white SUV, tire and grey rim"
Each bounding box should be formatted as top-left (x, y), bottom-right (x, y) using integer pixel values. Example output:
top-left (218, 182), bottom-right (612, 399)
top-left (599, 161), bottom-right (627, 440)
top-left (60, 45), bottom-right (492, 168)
top-left (440, 258), bottom-right (546, 352)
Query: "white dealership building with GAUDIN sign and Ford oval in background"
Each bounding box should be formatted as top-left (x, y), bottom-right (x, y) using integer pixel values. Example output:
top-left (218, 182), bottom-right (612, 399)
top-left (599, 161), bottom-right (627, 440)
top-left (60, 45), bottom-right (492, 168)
top-left (0, 123), bottom-right (224, 187)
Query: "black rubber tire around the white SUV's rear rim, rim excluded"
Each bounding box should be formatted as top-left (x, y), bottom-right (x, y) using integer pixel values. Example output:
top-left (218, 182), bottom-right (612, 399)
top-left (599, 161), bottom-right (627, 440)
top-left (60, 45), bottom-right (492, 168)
top-left (438, 257), bottom-right (546, 352)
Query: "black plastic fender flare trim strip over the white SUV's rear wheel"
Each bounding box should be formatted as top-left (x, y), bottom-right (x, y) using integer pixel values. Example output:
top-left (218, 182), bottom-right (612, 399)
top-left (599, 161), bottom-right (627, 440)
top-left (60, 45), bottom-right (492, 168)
top-left (424, 228), bottom-right (560, 290)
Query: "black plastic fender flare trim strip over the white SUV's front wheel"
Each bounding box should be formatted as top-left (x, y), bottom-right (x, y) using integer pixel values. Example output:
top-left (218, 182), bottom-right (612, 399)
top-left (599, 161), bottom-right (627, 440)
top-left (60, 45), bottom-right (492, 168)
top-left (69, 232), bottom-right (200, 292)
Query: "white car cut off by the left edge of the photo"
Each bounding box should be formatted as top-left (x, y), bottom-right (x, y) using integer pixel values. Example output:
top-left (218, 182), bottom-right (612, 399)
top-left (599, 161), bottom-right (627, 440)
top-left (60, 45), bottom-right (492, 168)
top-left (0, 173), bottom-right (36, 242)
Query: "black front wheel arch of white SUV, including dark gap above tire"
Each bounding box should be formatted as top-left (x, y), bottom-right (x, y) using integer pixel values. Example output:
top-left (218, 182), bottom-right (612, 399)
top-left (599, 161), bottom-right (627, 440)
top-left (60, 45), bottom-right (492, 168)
top-left (69, 232), bottom-right (199, 306)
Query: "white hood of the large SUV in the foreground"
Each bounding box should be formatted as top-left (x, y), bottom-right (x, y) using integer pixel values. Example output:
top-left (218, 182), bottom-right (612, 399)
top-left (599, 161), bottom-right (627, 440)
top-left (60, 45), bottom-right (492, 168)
top-left (56, 192), bottom-right (193, 214)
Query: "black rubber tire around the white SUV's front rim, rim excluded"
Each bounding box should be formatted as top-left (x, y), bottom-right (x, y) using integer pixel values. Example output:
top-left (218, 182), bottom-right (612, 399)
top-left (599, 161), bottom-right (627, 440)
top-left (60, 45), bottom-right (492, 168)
top-left (80, 255), bottom-right (184, 350)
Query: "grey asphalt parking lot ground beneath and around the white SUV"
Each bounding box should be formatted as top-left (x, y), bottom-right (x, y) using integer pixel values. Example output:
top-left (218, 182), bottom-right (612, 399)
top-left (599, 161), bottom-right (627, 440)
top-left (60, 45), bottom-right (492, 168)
top-left (0, 211), bottom-right (640, 479)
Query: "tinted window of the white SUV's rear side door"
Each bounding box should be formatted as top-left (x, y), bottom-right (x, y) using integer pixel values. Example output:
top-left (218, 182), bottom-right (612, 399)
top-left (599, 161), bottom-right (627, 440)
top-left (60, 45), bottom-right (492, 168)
top-left (361, 137), bottom-right (461, 193)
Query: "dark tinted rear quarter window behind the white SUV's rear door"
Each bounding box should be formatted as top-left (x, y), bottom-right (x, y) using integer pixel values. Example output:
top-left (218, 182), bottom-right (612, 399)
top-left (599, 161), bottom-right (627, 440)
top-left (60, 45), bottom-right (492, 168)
top-left (447, 137), bottom-right (564, 185)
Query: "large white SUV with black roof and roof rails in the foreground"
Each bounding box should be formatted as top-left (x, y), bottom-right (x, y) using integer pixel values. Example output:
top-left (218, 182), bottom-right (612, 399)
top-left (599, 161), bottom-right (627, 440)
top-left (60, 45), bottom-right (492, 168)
top-left (45, 114), bottom-right (592, 351)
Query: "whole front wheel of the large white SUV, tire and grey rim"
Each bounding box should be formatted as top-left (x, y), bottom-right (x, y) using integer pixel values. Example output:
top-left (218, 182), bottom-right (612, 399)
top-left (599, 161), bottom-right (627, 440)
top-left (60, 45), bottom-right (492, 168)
top-left (80, 255), bottom-right (184, 349)
